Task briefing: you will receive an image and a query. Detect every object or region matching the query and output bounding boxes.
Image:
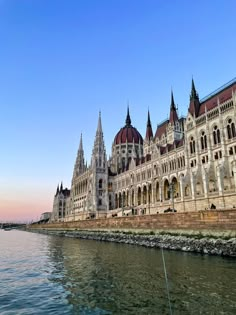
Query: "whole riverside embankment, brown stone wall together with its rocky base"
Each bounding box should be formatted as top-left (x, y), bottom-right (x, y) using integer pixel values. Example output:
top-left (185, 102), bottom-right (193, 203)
top-left (28, 209), bottom-right (236, 257)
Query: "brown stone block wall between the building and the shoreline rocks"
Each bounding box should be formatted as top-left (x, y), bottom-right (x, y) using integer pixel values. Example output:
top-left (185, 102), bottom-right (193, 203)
top-left (33, 209), bottom-right (236, 231)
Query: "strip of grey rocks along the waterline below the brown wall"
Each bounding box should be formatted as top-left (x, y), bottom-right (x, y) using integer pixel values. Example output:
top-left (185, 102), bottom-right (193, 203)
top-left (28, 229), bottom-right (236, 257)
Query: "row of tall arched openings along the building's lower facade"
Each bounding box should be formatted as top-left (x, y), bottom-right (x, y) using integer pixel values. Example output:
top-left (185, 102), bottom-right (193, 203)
top-left (115, 163), bottom-right (236, 209)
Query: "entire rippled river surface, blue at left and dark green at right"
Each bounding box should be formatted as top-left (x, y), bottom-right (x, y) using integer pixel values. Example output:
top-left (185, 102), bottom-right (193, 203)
top-left (0, 230), bottom-right (236, 315)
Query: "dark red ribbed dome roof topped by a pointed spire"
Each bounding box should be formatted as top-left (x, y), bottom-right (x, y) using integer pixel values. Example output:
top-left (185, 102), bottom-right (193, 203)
top-left (114, 108), bottom-right (143, 144)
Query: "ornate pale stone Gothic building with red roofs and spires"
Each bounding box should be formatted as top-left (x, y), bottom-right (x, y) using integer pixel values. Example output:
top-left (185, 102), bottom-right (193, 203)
top-left (51, 79), bottom-right (236, 221)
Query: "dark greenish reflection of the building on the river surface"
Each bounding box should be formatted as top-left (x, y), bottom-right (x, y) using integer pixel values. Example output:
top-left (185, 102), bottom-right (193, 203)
top-left (48, 237), bottom-right (236, 314)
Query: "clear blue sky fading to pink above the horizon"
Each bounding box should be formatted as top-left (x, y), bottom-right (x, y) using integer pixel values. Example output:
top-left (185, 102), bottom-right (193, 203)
top-left (0, 0), bottom-right (236, 221)
